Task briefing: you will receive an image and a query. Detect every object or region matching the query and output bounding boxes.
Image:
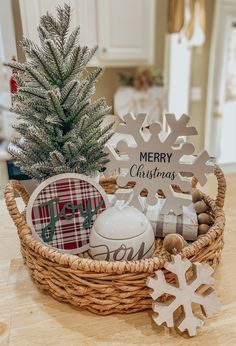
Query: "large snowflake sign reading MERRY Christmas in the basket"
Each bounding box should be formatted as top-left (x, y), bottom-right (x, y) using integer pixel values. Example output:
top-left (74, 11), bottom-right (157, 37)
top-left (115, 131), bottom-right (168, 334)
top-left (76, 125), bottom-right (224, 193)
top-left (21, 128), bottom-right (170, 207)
top-left (105, 114), bottom-right (212, 215)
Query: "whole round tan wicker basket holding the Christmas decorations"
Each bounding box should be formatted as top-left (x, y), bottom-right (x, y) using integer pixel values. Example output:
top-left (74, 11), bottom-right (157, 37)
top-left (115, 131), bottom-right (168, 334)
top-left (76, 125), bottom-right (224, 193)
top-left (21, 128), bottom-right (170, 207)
top-left (5, 166), bottom-right (226, 315)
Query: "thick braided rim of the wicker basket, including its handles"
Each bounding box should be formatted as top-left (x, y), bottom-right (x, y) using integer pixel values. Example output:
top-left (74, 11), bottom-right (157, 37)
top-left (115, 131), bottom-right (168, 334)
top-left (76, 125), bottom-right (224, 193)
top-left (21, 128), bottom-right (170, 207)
top-left (5, 166), bottom-right (226, 274)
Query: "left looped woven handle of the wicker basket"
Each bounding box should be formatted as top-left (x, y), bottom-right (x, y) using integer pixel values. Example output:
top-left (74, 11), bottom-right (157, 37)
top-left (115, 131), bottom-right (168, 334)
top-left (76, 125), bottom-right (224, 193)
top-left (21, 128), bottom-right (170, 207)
top-left (4, 180), bottom-right (30, 229)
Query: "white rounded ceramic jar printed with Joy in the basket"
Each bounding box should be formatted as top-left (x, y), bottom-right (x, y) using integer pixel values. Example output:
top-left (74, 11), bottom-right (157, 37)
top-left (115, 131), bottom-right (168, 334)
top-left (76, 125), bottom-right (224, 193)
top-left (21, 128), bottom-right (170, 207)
top-left (89, 206), bottom-right (155, 261)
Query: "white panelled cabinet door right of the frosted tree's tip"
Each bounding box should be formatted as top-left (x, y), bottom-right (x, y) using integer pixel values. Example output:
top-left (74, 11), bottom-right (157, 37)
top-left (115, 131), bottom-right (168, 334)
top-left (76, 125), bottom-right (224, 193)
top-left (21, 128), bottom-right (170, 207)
top-left (97, 0), bottom-right (155, 66)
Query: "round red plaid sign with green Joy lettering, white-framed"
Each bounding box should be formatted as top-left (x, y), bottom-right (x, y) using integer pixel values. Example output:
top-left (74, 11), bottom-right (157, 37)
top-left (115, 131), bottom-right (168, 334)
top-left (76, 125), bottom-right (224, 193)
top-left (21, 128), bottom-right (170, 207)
top-left (26, 173), bottom-right (108, 253)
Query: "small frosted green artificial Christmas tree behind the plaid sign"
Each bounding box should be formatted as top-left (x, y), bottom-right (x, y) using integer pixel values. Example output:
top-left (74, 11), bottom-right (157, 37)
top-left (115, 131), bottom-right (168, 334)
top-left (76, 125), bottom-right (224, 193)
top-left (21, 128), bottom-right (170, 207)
top-left (5, 5), bottom-right (112, 181)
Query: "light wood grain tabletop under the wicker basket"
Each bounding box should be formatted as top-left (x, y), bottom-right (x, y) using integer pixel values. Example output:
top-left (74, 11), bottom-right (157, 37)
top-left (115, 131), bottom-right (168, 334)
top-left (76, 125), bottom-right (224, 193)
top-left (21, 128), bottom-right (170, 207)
top-left (0, 175), bottom-right (236, 346)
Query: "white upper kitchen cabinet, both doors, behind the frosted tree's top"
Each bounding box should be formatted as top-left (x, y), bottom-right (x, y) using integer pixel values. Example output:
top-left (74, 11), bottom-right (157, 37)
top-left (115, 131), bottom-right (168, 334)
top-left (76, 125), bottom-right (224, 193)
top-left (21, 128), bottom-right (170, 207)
top-left (20, 0), bottom-right (155, 67)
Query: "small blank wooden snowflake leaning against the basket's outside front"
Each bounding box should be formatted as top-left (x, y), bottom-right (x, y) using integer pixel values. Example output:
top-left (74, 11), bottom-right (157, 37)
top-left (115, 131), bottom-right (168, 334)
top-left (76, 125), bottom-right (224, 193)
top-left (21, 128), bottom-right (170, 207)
top-left (147, 255), bottom-right (219, 336)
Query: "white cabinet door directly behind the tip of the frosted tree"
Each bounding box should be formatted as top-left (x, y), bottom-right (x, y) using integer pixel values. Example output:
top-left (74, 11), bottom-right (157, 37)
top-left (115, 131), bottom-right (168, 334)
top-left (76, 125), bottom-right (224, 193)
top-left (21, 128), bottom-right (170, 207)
top-left (20, 0), bottom-right (97, 51)
